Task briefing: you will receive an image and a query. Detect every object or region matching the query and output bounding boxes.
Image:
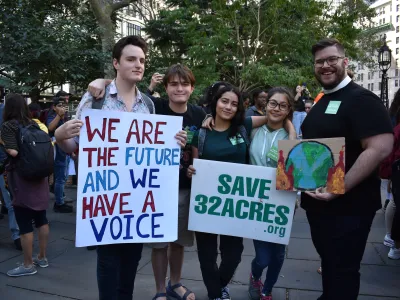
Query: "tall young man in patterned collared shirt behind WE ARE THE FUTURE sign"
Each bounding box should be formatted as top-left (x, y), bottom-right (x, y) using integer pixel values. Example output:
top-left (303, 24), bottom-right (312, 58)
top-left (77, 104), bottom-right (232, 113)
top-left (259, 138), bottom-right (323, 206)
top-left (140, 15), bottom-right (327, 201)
top-left (55, 36), bottom-right (186, 300)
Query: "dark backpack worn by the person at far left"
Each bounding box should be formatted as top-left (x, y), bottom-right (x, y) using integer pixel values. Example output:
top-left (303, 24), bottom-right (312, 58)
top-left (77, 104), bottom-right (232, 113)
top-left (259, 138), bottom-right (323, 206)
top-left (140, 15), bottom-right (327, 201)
top-left (14, 123), bottom-right (54, 180)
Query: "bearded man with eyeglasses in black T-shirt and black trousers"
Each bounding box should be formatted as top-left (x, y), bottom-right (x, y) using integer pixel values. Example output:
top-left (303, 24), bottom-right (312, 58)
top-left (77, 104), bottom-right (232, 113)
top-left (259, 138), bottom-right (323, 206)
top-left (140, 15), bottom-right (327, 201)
top-left (301, 39), bottom-right (393, 300)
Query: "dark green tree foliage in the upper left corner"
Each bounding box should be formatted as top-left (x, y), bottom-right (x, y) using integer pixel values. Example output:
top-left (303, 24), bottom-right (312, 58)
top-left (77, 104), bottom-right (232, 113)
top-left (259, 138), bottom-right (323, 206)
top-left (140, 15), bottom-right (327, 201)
top-left (0, 0), bottom-right (104, 101)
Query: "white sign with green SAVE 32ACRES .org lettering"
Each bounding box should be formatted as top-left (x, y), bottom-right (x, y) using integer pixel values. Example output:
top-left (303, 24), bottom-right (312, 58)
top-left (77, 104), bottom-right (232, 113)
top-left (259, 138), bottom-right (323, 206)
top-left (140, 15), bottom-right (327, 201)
top-left (189, 159), bottom-right (296, 245)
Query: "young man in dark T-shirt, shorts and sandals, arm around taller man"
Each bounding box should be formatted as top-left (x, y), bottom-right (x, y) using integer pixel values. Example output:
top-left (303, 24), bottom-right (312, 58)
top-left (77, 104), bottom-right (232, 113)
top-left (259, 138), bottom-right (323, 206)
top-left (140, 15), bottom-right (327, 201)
top-left (85, 64), bottom-right (205, 300)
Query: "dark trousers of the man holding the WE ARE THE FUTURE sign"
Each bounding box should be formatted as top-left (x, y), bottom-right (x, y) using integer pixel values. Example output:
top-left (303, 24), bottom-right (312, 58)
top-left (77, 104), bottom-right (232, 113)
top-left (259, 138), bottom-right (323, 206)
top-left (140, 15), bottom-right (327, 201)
top-left (97, 244), bottom-right (143, 300)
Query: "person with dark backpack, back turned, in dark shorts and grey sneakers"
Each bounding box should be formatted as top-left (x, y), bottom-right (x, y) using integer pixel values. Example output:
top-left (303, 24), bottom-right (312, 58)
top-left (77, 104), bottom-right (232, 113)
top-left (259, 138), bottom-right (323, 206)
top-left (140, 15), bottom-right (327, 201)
top-left (0, 94), bottom-right (54, 277)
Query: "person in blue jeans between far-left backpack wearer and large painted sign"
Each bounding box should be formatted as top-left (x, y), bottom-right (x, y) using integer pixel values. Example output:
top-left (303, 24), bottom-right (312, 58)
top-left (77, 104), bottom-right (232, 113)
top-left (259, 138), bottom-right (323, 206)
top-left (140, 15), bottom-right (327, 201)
top-left (46, 91), bottom-right (73, 213)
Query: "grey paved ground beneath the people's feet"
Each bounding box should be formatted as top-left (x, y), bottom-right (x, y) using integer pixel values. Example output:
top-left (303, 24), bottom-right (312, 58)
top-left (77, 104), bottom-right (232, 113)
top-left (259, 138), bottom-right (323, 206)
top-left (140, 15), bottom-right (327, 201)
top-left (0, 189), bottom-right (400, 300)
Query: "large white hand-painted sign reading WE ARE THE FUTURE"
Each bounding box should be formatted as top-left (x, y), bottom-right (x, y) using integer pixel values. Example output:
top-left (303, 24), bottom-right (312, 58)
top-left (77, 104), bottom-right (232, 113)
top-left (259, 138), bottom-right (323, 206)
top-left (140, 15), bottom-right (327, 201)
top-left (76, 109), bottom-right (182, 247)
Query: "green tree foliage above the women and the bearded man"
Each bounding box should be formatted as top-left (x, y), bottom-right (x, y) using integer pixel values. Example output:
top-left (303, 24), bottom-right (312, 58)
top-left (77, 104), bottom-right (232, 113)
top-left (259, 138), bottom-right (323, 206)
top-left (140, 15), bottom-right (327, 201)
top-left (145, 0), bottom-right (374, 99)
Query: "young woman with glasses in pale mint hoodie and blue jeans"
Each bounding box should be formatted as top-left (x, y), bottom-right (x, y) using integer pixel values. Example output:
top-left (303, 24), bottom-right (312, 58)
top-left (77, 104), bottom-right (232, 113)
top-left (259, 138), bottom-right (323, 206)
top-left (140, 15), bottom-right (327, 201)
top-left (249, 87), bottom-right (294, 300)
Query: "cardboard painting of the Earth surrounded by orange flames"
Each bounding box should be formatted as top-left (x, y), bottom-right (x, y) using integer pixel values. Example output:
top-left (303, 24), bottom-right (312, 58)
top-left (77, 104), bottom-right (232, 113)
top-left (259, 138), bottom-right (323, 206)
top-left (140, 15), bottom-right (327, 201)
top-left (276, 138), bottom-right (345, 194)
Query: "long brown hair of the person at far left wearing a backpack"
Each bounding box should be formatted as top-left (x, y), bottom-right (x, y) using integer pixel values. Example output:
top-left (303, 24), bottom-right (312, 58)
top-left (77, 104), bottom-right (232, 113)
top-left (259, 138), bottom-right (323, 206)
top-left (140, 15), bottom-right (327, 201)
top-left (3, 93), bottom-right (31, 126)
